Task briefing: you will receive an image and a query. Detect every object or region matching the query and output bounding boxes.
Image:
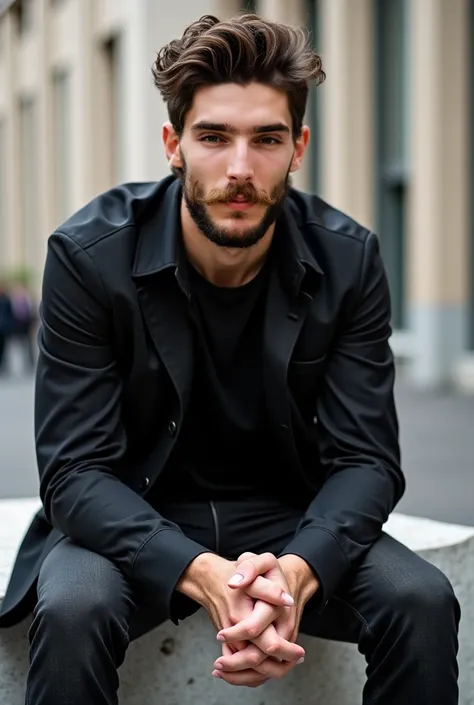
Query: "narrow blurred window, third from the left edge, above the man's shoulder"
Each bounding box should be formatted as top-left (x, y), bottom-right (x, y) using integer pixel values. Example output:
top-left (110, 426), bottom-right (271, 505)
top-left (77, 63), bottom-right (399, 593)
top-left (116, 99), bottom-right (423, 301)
top-left (53, 71), bottom-right (71, 223)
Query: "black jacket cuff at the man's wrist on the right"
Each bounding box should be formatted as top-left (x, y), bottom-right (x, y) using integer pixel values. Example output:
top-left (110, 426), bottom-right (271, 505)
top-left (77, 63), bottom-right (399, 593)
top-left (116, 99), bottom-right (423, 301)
top-left (279, 526), bottom-right (351, 611)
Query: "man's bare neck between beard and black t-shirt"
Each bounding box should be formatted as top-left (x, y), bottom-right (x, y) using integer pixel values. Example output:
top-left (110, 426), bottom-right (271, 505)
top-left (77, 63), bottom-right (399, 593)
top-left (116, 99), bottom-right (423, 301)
top-left (181, 200), bottom-right (275, 287)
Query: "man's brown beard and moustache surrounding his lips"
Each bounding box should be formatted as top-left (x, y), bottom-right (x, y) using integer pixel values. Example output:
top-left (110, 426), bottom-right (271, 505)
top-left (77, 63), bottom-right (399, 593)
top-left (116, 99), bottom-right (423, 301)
top-left (174, 160), bottom-right (291, 249)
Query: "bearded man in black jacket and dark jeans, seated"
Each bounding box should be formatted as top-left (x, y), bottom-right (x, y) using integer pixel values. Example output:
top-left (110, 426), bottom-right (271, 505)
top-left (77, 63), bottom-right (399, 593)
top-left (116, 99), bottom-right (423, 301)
top-left (3, 15), bottom-right (459, 705)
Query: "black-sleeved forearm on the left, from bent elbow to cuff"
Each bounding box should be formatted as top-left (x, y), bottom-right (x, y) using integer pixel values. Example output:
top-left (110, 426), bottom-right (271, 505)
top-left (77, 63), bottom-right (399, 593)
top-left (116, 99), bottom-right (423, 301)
top-left (42, 469), bottom-right (207, 616)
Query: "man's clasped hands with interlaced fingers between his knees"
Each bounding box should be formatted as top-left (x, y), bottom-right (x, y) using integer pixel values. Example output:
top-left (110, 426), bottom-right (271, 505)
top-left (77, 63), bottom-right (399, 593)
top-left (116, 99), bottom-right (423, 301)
top-left (204, 553), bottom-right (318, 687)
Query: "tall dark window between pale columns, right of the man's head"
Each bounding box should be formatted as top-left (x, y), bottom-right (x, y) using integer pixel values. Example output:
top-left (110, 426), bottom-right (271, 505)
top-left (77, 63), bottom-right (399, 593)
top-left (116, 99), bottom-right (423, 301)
top-left (374, 0), bottom-right (409, 329)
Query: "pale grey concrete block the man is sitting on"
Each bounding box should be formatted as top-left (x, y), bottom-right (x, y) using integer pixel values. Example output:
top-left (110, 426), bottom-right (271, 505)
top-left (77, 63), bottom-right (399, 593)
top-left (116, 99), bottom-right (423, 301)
top-left (0, 500), bottom-right (474, 705)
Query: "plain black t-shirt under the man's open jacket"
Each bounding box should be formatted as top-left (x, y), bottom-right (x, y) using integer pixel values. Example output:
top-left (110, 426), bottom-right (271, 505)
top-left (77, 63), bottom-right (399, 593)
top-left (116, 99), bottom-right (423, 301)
top-left (159, 254), bottom-right (278, 499)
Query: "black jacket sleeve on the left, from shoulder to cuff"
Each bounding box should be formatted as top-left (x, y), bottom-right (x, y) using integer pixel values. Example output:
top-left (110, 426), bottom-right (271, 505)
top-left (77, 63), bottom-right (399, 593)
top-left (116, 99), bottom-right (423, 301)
top-left (35, 233), bottom-right (208, 607)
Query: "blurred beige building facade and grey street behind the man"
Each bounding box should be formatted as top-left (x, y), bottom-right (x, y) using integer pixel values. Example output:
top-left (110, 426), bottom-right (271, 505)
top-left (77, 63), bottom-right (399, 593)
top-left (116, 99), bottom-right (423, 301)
top-left (0, 0), bottom-right (474, 525)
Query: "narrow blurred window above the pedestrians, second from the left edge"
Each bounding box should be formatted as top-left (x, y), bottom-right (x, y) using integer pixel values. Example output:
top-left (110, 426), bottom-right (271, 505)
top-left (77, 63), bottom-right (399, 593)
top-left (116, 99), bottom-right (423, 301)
top-left (19, 98), bottom-right (38, 269)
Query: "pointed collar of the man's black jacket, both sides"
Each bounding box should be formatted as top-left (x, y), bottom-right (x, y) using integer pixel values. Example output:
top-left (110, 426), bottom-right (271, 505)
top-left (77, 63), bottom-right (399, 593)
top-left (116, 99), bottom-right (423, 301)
top-left (132, 176), bottom-right (324, 296)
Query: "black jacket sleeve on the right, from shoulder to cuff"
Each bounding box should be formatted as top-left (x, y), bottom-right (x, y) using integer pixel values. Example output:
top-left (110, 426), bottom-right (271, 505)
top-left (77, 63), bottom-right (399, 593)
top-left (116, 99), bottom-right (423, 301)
top-left (281, 234), bottom-right (405, 606)
